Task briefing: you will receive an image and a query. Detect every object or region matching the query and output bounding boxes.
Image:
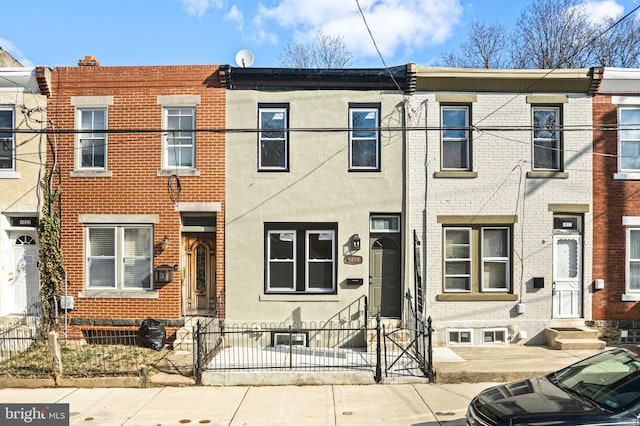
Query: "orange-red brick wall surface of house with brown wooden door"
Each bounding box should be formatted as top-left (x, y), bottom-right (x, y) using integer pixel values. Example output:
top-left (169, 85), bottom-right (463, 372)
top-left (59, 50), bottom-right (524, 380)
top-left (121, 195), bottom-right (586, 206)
top-left (48, 65), bottom-right (226, 331)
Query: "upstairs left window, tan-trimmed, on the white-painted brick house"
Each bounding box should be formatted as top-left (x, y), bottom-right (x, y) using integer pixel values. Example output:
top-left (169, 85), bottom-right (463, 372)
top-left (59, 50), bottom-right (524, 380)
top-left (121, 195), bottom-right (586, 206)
top-left (441, 106), bottom-right (471, 170)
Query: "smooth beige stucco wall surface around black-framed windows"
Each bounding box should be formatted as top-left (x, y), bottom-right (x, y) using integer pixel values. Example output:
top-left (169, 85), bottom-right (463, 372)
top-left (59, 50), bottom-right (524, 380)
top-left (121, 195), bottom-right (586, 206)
top-left (225, 90), bottom-right (403, 322)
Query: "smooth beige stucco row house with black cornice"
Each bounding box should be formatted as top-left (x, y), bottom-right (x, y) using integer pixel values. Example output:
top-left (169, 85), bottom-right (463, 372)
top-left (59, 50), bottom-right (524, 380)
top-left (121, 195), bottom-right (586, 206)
top-left (225, 66), bottom-right (411, 323)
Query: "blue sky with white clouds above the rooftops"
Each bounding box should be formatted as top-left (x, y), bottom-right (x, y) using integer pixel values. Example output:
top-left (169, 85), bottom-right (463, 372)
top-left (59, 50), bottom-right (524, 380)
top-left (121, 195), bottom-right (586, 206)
top-left (0, 0), bottom-right (640, 68)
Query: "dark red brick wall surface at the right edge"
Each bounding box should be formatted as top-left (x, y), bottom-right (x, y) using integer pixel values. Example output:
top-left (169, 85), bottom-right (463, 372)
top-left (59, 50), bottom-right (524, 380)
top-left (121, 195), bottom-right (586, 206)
top-left (593, 95), bottom-right (640, 320)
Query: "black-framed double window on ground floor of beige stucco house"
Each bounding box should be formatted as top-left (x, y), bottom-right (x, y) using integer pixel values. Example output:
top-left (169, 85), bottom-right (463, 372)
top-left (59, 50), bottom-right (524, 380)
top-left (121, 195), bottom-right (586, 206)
top-left (265, 224), bottom-right (337, 293)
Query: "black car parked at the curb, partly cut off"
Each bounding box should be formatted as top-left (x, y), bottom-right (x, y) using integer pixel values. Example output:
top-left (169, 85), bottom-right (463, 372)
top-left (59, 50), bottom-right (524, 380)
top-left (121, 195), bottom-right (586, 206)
top-left (467, 348), bottom-right (640, 426)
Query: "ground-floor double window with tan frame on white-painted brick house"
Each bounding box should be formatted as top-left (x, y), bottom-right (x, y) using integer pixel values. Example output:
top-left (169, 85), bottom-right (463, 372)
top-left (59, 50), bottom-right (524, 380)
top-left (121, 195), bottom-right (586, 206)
top-left (443, 226), bottom-right (511, 293)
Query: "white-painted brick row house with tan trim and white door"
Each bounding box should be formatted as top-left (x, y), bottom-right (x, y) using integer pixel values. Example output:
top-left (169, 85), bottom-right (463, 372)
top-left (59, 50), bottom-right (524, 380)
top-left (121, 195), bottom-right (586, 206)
top-left (406, 67), bottom-right (599, 345)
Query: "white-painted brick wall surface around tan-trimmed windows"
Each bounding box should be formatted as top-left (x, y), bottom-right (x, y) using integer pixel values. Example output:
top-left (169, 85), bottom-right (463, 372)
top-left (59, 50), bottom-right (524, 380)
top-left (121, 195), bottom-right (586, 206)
top-left (407, 92), bottom-right (593, 345)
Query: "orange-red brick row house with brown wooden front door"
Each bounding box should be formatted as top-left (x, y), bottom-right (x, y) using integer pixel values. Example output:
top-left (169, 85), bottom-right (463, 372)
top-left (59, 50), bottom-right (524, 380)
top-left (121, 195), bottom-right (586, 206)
top-left (48, 56), bottom-right (226, 335)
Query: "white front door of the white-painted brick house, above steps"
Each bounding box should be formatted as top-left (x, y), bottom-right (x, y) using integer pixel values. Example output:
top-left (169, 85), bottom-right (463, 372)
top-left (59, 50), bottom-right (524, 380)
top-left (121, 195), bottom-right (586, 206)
top-left (553, 235), bottom-right (582, 318)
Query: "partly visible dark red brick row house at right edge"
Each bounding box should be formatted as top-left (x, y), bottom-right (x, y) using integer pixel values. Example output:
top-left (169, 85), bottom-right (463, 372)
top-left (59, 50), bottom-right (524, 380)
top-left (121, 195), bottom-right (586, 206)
top-left (593, 68), bottom-right (640, 343)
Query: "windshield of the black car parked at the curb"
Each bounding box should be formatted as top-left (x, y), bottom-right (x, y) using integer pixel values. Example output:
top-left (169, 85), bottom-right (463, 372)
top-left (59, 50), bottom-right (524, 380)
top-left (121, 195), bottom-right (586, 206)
top-left (554, 349), bottom-right (640, 411)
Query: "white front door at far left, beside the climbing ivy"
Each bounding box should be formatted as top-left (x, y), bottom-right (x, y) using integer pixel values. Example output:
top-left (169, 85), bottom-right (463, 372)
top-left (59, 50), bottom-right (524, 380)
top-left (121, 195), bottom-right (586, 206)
top-left (8, 234), bottom-right (39, 314)
